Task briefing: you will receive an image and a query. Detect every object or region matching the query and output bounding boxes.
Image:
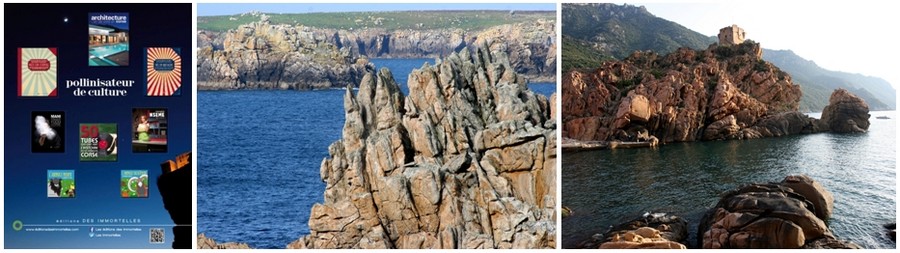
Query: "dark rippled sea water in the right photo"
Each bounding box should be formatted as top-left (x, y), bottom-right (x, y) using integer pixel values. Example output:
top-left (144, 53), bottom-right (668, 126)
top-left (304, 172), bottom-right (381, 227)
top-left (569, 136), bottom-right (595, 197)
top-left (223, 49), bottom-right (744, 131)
top-left (562, 111), bottom-right (898, 248)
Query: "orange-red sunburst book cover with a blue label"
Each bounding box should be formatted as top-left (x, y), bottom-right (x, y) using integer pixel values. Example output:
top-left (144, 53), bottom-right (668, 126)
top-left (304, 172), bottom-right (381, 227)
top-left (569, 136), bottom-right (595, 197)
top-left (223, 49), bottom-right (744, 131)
top-left (144, 47), bottom-right (181, 96)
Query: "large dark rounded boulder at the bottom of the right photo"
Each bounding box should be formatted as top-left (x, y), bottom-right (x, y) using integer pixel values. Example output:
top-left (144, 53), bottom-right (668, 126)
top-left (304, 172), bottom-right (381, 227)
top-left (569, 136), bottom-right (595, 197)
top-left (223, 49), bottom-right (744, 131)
top-left (697, 175), bottom-right (859, 249)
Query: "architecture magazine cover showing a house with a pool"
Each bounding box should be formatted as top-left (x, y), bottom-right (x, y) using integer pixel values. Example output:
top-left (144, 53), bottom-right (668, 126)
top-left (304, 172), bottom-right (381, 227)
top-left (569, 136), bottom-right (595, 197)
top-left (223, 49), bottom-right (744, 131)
top-left (88, 12), bottom-right (131, 66)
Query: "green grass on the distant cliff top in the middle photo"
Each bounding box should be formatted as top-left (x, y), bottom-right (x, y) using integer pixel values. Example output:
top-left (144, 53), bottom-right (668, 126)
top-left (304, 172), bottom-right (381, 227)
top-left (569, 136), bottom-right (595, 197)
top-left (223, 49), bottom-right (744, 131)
top-left (197, 10), bottom-right (556, 32)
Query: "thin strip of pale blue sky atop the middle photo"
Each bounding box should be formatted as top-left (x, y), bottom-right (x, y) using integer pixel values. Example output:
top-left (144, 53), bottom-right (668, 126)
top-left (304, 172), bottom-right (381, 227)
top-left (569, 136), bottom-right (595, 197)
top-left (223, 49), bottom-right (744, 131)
top-left (197, 3), bottom-right (556, 16)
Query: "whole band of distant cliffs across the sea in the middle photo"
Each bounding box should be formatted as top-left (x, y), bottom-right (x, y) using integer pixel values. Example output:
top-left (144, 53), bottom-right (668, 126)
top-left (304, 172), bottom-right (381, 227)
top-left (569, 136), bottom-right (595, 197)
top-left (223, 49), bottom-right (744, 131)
top-left (197, 15), bottom-right (557, 90)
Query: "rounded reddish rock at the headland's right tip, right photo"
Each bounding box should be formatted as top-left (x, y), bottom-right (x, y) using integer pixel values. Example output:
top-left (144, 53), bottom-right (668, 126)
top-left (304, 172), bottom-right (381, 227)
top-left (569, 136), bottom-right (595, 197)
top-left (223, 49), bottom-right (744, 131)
top-left (821, 89), bottom-right (870, 133)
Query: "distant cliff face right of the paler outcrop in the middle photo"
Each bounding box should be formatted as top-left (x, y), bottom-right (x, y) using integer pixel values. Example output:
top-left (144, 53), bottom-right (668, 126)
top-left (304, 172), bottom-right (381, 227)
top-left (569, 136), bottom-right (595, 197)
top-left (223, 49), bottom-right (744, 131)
top-left (323, 19), bottom-right (556, 81)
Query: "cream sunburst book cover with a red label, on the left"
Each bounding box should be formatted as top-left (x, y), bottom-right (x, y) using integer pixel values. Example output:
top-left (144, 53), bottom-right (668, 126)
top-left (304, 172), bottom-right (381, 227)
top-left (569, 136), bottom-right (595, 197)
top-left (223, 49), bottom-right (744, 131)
top-left (17, 47), bottom-right (58, 97)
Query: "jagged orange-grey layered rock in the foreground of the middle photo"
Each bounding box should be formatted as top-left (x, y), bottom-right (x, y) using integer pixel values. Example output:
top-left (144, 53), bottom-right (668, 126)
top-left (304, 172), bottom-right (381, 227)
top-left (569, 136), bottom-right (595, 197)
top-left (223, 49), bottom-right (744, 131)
top-left (288, 46), bottom-right (556, 248)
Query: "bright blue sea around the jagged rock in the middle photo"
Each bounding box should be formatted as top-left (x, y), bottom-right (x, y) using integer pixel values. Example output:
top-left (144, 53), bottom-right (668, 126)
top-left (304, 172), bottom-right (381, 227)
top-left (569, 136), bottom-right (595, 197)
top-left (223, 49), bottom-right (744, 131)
top-left (197, 59), bottom-right (556, 248)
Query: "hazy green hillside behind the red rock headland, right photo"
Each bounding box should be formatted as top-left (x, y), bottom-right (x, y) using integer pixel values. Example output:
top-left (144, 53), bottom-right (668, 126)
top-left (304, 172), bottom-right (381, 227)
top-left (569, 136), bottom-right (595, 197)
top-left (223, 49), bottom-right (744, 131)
top-left (561, 3), bottom-right (896, 112)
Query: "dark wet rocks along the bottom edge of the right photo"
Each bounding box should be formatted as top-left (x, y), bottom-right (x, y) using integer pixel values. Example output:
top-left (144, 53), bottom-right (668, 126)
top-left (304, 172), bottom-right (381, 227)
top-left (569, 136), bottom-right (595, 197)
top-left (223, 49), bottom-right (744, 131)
top-left (580, 175), bottom-right (860, 249)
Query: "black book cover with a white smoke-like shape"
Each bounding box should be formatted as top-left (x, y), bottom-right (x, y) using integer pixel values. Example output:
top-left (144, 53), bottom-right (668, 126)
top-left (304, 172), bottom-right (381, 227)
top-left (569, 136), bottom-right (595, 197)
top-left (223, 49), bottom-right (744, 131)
top-left (31, 111), bottom-right (66, 153)
